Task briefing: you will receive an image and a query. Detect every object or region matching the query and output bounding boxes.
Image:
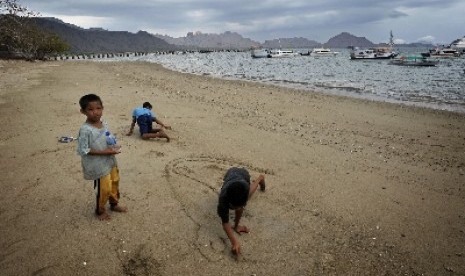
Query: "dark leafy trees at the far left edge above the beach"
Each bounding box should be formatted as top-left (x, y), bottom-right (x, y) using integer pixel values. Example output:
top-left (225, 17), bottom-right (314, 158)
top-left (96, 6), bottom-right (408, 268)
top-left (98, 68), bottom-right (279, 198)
top-left (0, 0), bottom-right (70, 60)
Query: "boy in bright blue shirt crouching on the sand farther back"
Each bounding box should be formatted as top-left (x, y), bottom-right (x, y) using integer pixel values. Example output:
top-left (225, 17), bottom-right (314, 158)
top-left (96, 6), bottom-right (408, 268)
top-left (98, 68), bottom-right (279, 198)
top-left (127, 102), bottom-right (171, 142)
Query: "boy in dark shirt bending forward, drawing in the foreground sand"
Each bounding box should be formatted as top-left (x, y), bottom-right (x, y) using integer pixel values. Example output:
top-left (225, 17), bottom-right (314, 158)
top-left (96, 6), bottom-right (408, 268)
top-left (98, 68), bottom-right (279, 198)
top-left (217, 167), bottom-right (265, 255)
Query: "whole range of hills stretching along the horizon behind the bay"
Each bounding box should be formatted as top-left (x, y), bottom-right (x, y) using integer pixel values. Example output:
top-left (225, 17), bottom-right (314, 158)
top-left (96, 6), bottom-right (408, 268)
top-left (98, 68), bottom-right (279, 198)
top-left (33, 17), bottom-right (429, 53)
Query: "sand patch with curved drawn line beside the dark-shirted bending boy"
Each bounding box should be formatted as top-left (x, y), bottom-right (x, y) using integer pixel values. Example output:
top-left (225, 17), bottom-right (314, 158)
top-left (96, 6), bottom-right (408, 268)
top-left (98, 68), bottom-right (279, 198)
top-left (164, 156), bottom-right (274, 262)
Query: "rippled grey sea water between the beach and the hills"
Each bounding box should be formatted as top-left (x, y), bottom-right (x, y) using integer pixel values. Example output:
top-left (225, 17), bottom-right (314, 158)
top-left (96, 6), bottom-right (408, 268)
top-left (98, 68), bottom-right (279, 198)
top-left (104, 48), bottom-right (465, 113)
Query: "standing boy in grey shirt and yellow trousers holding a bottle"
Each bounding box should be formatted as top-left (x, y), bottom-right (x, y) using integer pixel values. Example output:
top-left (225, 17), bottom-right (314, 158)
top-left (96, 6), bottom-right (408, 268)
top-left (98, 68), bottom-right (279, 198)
top-left (77, 94), bottom-right (127, 220)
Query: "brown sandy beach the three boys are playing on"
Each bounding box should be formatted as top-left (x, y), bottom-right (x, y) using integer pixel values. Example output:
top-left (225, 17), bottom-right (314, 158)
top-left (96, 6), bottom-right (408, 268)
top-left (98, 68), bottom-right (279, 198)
top-left (0, 61), bottom-right (465, 275)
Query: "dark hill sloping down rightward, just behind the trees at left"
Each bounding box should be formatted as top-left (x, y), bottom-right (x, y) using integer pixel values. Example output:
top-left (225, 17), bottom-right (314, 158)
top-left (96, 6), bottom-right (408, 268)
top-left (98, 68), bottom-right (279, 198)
top-left (32, 17), bottom-right (177, 53)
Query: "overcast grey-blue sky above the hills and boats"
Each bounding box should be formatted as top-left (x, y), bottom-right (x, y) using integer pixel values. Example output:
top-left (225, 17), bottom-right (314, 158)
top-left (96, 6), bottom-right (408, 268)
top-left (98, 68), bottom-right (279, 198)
top-left (17, 0), bottom-right (465, 44)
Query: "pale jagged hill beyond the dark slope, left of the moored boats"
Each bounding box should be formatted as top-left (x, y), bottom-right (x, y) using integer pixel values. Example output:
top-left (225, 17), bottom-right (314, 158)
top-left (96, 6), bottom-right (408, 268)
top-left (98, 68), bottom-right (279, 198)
top-left (155, 32), bottom-right (260, 50)
